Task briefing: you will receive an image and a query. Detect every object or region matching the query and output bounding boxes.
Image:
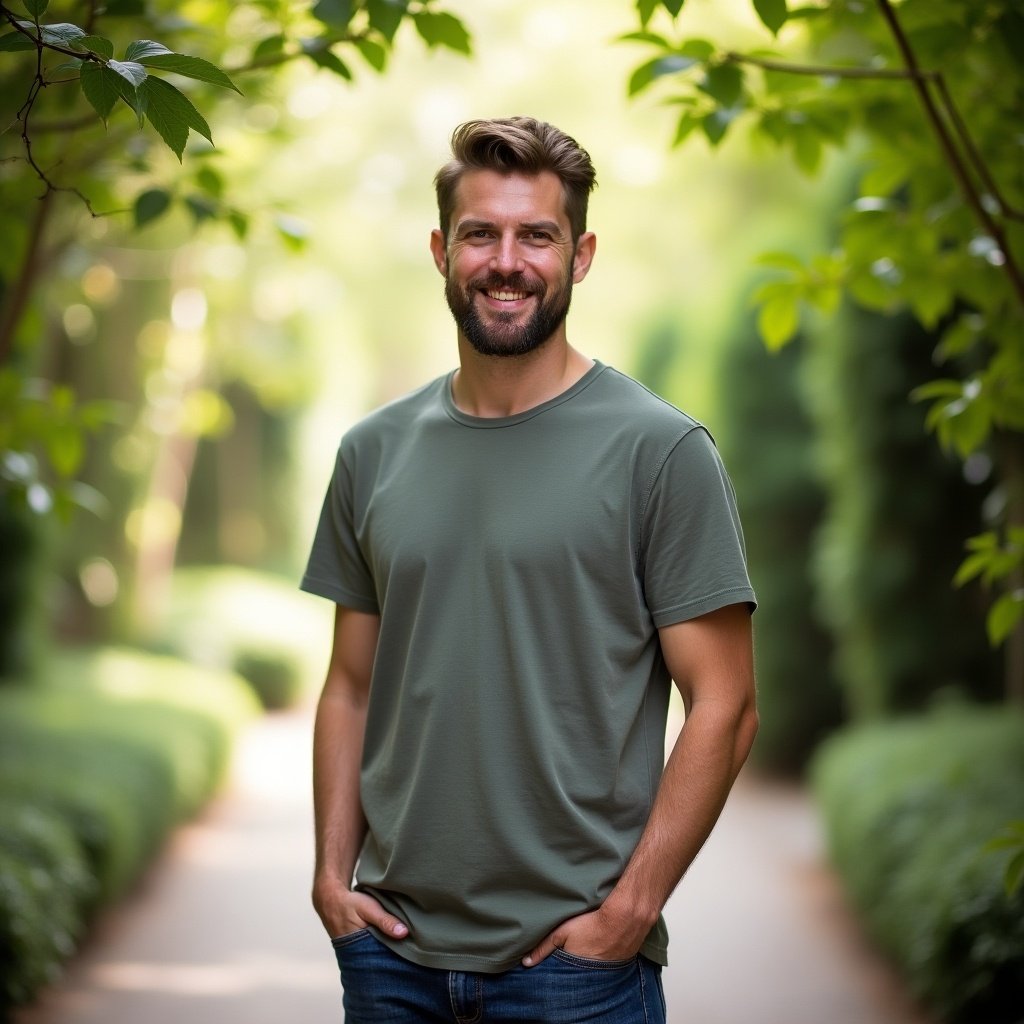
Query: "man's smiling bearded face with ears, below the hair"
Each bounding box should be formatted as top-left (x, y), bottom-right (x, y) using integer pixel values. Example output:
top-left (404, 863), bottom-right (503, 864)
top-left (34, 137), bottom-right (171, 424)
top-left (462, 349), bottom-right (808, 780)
top-left (431, 171), bottom-right (593, 356)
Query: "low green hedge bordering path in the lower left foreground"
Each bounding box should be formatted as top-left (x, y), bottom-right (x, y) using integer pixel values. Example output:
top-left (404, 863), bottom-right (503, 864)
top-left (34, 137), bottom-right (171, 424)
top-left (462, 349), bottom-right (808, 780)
top-left (0, 649), bottom-right (256, 1018)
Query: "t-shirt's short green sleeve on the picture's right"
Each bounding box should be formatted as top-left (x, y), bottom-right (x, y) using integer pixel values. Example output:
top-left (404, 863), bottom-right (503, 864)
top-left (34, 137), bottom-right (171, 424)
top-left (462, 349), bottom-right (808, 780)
top-left (641, 426), bottom-right (756, 628)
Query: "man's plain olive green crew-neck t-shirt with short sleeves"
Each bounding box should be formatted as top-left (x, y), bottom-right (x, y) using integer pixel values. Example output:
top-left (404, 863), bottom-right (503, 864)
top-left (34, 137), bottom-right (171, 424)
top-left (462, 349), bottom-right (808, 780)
top-left (302, 364), bottom-right (755, 972)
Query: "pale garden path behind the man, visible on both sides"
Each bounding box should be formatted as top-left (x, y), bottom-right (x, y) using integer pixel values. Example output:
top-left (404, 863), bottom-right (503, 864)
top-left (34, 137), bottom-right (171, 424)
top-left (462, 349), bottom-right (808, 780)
top-left (15, 710), bottom-right (929, 1024)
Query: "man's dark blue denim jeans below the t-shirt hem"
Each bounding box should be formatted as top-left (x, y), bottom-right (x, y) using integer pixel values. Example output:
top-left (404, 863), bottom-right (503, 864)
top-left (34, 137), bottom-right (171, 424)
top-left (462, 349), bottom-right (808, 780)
top-left (333, 929), bottom-right (666, 1024)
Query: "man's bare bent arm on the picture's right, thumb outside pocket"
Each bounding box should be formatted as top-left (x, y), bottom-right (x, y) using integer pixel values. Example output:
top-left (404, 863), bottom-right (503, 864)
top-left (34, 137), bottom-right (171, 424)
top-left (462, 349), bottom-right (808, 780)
top-left (523, 604), bottom-right (758, 967)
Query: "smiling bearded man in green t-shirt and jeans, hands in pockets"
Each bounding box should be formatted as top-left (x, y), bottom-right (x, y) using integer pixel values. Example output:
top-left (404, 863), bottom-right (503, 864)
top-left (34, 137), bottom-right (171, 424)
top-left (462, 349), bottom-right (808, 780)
top-left (302, 118), bottom-right (757, 1024)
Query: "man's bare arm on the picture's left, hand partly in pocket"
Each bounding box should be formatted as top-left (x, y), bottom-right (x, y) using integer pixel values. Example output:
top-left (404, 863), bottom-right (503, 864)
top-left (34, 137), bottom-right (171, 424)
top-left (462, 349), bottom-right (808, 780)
top-left (312, 605), bottom-right (409, 939)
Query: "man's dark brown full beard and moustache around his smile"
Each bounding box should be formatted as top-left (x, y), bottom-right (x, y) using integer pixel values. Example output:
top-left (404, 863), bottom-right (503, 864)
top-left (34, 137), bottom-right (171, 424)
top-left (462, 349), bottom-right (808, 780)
top-left (444, 273), bottom-right (572, 356)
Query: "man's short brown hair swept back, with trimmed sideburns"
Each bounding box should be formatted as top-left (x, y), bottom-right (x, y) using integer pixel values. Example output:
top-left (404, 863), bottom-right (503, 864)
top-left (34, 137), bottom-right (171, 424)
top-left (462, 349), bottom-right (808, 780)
top-left (434, 117), bottom-right (597, 242)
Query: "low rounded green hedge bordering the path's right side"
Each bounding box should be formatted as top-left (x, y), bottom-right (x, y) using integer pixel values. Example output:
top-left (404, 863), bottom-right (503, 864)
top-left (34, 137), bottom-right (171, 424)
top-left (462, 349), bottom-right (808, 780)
top-left (812, 707), bottom-right (1024, 1024)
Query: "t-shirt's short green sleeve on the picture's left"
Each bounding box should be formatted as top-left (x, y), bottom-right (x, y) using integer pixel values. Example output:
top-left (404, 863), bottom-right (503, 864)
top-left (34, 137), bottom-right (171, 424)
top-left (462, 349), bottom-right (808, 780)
top-left (300, 443), bottom-right (380, 613)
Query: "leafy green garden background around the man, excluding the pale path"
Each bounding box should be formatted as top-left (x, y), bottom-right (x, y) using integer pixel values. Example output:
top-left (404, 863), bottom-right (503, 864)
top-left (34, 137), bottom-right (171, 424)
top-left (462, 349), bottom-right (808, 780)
top-left (0, 0), bottom-right (1024, 1024)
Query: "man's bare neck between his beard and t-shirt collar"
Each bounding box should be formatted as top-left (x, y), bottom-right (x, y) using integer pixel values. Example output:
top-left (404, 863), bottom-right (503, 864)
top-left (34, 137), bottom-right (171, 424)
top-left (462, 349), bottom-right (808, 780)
top-left (452, 336), bottom-right (594, 419)
